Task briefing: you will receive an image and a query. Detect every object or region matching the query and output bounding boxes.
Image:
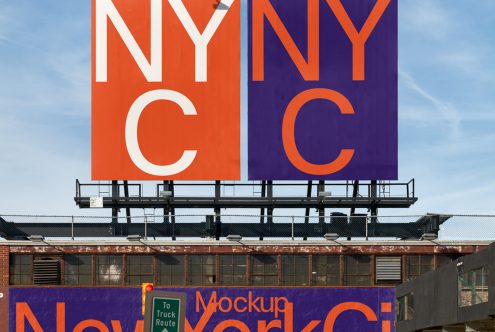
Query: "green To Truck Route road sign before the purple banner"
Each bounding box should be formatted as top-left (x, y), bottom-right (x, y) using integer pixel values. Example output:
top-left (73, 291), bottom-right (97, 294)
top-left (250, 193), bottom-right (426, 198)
top-left (144, 291), bottom-right (186, 332)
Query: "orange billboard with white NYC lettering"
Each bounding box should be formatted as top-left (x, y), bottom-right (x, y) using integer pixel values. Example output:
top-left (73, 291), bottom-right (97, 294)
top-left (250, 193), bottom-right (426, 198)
top-left (91, 0), bottom-right (240, 180)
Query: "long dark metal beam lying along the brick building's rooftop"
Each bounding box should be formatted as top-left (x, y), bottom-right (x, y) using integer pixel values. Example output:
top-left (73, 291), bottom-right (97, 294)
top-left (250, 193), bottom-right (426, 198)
top-left (0, 216), bottom-right (449, 240)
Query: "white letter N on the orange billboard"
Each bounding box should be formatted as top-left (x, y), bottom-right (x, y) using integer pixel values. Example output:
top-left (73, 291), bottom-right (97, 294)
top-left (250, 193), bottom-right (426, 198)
top-left (95, 0), bottom-right (162, 82)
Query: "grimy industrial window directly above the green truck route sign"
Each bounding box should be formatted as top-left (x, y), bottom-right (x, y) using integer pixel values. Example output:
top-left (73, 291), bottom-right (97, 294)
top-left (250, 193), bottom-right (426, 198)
top-left (156, 255), bottom-right (185, 286)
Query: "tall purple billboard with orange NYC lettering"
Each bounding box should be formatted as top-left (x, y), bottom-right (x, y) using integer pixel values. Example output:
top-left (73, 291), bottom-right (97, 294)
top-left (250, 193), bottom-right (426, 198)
top-left (248, 0), bottom-right (397, 180)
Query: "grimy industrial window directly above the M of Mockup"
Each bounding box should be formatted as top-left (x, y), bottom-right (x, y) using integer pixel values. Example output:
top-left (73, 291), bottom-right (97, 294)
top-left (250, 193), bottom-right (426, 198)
top-left (188, 255), bottom-right (217, 285)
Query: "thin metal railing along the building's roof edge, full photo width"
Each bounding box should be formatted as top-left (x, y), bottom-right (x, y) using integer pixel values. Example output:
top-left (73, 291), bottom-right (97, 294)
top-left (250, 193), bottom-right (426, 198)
top-left (0, 212), bottom-right (495, 240)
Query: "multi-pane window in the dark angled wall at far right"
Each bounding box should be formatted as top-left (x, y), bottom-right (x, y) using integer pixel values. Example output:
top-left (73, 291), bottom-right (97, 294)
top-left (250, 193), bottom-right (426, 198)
top-left (457, 267), bottom-right (488, 307)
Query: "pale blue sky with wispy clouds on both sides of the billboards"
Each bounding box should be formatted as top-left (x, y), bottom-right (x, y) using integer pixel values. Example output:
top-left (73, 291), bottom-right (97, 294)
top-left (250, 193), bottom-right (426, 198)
top-left (0, 0), bottom-right (495, 215)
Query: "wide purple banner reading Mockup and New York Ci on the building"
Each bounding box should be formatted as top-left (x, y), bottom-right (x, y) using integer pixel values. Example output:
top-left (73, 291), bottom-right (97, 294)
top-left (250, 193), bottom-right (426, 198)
top-left (9, 288), bottom-right (395, 332)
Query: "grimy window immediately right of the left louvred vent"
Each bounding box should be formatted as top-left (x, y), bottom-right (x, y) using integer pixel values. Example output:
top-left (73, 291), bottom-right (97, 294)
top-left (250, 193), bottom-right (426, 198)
top-left (64, 255), bottom-right (93, 285)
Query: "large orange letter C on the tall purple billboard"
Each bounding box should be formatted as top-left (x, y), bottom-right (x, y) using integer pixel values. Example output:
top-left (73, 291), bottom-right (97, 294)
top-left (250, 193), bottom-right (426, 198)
top-left (282, 88), bottom-right (354, 175)
